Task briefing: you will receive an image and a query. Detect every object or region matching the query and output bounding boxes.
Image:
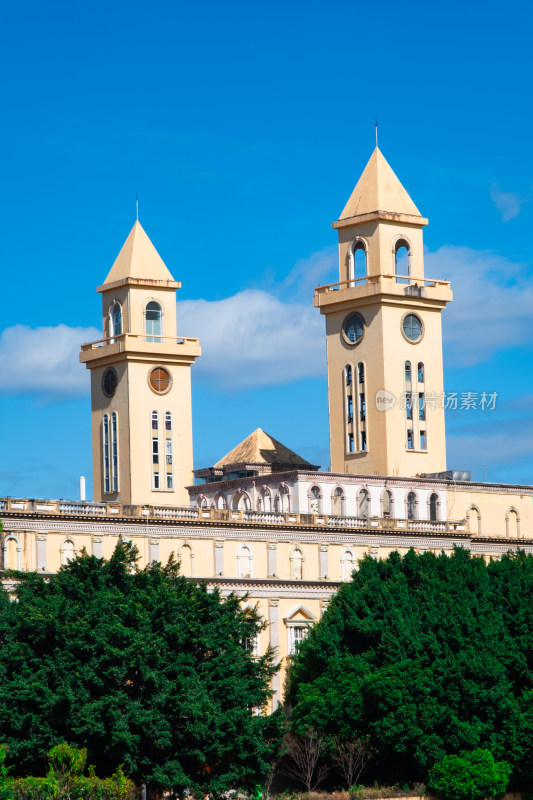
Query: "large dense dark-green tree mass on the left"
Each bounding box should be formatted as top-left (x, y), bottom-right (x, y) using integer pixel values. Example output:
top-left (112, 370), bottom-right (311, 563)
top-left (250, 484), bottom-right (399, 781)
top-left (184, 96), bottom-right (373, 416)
top-left (0, 542), bottom-right (273, 795)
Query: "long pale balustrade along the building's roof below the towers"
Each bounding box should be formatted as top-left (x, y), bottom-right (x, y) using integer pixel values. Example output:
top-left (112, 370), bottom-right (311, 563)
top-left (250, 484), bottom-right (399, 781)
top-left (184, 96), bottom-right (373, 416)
top-left (0, 497), bottom-right (468, 534)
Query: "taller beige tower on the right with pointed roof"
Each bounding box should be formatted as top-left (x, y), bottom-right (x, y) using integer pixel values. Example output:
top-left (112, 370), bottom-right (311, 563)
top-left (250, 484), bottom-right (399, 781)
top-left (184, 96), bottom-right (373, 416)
top-left (314, 147), bottom-right (452, 477)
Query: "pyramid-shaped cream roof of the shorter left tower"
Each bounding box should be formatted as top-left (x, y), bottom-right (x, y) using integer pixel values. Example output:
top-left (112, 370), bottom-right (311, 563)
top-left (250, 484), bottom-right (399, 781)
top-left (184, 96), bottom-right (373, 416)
top-left (104, 220), bottom-right (174, 286)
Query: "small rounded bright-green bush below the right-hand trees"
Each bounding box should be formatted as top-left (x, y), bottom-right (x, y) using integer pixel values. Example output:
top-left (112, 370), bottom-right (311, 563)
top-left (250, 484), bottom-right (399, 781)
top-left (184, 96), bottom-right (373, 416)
top-left (428, 749), bottom-right (511, 800)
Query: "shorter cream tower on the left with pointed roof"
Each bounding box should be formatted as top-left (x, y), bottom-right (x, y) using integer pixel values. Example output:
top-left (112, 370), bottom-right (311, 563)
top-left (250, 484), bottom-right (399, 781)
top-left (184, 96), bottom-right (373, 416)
top-left (80, 221), bottom-right (200, 505)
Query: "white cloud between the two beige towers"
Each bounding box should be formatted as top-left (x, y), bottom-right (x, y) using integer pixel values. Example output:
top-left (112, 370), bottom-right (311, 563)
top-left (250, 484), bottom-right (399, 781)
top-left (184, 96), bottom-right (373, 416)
top-left (178, 289), bottom-right (326, 391)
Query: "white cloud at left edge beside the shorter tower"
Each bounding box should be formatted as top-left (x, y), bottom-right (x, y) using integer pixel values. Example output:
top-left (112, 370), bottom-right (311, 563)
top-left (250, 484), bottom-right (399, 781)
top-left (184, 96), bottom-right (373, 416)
top-left (0, 325), bottom-right (101, 399)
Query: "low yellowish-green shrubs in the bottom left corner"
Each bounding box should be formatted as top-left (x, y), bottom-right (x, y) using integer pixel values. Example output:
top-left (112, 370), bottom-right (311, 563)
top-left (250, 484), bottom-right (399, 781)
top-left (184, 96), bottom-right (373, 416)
top-left (0, 743), bottom-right (139, 800)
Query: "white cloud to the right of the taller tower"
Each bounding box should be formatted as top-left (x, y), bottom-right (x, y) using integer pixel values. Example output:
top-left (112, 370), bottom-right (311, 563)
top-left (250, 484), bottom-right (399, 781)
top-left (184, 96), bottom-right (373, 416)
top-left (425, 245), bottom-right (533, 367)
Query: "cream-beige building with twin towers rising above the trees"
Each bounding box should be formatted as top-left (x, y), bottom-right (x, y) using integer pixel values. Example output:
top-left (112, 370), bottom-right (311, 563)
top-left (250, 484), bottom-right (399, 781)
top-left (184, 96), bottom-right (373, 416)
top-left (0, 149), bottom-right (533, 707)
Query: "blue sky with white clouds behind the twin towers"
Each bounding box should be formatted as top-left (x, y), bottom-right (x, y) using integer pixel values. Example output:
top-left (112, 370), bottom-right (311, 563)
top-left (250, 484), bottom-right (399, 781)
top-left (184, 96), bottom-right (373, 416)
top-left (0, 0), bottom-right (533, 497)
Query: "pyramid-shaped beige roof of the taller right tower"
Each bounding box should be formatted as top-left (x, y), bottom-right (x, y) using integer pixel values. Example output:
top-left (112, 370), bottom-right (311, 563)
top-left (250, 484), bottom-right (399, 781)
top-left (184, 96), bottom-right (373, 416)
top-left (339, 147), bottom-right (422, 219)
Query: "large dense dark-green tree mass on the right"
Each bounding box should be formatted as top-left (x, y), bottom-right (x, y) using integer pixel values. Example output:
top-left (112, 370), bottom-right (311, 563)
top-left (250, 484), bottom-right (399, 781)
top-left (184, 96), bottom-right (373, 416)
top-left (288, 549), bottom-right (533, 789)
